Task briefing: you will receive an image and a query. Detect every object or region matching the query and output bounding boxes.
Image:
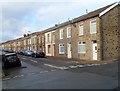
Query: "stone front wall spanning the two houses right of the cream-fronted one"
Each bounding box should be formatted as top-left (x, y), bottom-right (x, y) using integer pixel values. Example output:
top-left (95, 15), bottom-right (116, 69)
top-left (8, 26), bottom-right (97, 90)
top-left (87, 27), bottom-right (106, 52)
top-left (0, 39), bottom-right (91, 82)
top-left (55, 17), bottom-right (101, 60)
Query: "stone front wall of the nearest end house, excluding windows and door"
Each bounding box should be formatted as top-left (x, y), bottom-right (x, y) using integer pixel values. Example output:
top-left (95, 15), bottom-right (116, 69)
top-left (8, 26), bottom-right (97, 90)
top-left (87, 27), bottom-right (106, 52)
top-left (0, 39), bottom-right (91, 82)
top-left (72, 17), bottom-right (101, 60)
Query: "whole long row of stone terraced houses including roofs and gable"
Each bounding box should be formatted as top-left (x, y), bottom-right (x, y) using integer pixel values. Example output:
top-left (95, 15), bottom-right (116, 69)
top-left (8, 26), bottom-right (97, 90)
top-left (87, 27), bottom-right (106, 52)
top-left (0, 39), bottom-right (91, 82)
top-left (1, 2), bottom-right (120, 61)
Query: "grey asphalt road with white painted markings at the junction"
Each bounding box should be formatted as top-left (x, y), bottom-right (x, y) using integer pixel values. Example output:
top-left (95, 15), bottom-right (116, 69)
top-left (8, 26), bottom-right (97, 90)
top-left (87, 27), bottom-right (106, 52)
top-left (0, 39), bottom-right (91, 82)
top-left (2, 56), bottom-right (118, 89)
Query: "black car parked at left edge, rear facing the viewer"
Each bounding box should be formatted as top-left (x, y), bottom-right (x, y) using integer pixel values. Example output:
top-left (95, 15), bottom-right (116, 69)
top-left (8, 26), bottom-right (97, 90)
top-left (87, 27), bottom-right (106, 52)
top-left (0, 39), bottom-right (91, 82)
top-left (0, 51), bottom-right (21, 68)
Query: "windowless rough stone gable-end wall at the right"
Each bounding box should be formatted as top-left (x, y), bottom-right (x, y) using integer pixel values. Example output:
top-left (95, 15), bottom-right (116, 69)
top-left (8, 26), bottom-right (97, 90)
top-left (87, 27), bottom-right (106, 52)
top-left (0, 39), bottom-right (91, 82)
top-left (100, 6), bottom-right (120, 60)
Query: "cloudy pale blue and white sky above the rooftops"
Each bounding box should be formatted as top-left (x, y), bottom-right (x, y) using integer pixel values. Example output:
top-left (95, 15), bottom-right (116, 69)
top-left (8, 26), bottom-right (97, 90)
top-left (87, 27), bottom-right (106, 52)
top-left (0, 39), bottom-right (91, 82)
top-left (0, 0), bottom-right (119, 42)
